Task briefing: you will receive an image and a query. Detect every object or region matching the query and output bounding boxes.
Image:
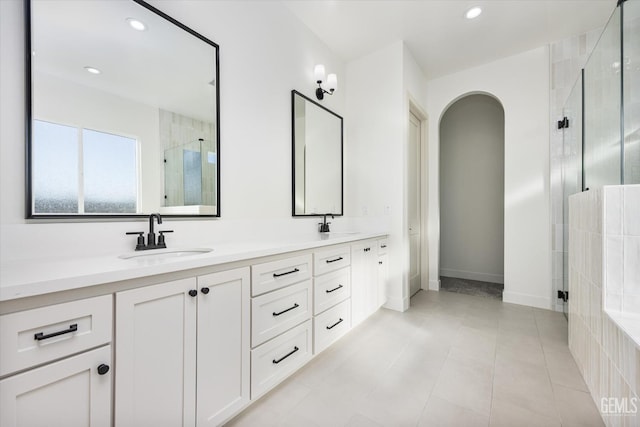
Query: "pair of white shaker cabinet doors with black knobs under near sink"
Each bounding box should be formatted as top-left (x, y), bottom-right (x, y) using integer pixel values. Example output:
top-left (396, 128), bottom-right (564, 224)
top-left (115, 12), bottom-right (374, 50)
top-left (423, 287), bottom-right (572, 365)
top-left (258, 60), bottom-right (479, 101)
top-left (115, 268), bottom-right (250, 427)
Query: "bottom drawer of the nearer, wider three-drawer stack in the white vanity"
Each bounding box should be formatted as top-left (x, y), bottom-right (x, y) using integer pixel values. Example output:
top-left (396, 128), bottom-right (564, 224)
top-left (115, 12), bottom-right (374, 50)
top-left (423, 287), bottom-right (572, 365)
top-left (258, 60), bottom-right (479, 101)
top-left (251, 320), bottom-right (311, 400)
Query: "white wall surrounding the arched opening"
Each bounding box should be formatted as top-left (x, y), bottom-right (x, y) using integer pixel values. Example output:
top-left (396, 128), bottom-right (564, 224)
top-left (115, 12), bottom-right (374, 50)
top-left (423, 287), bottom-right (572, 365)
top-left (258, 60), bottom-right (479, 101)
top-left (427, 46), bottom-right (552, 308)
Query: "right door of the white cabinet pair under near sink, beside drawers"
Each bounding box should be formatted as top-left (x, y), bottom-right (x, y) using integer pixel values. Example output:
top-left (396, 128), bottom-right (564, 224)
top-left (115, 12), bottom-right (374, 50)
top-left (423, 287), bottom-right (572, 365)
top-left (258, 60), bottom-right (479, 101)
top-left (196, 267), bottom-right (250, 427)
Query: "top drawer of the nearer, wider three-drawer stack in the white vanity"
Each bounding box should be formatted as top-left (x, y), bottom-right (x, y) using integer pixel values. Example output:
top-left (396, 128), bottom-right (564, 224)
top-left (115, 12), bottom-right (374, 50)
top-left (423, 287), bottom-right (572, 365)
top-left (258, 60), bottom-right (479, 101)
top-left (251, 254), bottom-right (311, 296)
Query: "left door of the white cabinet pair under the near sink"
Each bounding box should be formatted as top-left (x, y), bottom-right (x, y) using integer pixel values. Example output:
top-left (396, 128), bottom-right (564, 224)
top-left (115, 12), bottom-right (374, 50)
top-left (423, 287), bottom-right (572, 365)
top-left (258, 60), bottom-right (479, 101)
top-left (115, 278), bottom-right (197, 427)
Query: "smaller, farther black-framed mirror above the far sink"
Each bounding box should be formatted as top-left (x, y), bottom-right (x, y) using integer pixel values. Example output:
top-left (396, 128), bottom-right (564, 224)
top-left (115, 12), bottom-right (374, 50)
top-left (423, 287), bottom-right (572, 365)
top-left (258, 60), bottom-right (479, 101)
top-left (291, 90), bottom-right (343, 216)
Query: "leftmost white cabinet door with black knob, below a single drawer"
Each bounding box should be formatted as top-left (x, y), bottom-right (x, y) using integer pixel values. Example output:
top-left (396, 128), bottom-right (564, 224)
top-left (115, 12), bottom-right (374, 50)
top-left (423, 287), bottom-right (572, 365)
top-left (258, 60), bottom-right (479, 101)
top-left (0, 345), bottom-right (113, 427)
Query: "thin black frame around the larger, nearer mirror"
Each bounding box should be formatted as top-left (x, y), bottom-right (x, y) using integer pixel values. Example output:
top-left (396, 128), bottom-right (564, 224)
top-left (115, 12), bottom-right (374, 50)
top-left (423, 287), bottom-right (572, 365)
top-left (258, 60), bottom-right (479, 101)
top-left (24, 0), bottom-right (221, 220)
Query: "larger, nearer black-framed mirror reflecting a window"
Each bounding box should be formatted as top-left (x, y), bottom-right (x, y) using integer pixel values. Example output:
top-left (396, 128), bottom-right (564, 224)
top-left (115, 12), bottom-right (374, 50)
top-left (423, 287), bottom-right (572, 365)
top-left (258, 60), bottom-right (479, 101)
top-left (25, 0), bottom-right (220, 218)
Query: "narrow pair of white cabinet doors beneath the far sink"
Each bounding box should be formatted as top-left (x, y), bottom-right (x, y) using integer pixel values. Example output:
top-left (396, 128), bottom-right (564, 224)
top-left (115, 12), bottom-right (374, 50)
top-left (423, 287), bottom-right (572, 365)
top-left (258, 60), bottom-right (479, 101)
top-left (351, 240), bottom-right (378, 326)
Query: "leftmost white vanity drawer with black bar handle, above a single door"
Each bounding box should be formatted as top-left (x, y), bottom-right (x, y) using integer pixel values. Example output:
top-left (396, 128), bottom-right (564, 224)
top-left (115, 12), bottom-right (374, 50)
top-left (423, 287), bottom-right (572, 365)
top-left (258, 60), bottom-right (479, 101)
top-left (0, 295), bottom-right (112, 376)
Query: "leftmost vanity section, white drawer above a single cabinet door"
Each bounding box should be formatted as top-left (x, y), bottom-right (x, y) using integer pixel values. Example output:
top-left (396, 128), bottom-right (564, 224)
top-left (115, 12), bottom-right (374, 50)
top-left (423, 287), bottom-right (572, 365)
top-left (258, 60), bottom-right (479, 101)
top-left (0, 295), bottom-right (113, 427)
